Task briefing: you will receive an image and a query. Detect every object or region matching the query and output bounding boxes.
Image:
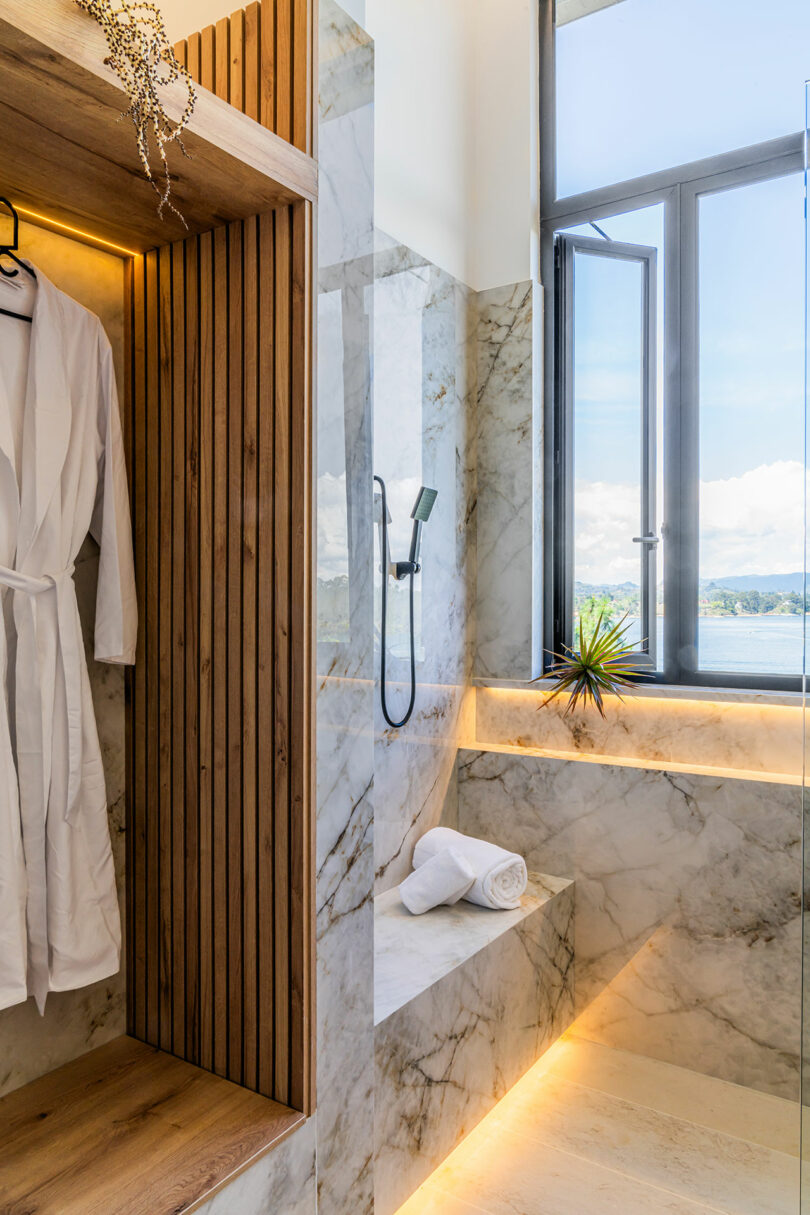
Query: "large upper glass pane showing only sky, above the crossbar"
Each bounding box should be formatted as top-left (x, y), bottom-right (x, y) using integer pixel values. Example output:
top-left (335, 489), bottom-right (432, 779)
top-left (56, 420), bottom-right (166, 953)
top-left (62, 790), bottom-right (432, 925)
top-left (555, 0), bottom-right (810, 198)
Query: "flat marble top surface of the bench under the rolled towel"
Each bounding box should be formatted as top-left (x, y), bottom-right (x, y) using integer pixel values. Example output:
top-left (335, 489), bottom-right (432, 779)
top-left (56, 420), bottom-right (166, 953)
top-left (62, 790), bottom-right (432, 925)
top-left (374, 874), bottom-right (573, 1025)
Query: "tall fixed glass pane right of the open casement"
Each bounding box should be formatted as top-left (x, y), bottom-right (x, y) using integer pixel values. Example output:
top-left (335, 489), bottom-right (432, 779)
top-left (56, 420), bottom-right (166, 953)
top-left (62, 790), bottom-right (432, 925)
top-left (698, 174), bottom-right (804, 674)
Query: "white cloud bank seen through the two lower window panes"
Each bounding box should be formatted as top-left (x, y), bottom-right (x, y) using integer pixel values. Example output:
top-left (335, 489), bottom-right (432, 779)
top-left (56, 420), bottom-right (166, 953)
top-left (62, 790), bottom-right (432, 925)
top-left (576, 460), bottom-right (804, 583)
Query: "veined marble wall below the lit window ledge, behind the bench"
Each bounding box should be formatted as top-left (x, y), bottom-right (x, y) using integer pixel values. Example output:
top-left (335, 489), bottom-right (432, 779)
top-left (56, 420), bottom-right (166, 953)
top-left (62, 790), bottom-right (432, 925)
top-left (458, 751), bottom-right (801, 1100)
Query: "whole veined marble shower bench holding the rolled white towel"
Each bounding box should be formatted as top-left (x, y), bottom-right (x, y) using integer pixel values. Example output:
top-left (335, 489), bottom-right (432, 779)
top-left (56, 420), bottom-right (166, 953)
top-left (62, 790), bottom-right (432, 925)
top-left (374, 874), bottom-right (573, 1215)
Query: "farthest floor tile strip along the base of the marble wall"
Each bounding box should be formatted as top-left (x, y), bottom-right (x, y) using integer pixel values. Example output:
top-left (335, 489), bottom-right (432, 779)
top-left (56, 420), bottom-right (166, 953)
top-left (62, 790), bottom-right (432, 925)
top-left (543, 1025), bottom-right (800, 1155)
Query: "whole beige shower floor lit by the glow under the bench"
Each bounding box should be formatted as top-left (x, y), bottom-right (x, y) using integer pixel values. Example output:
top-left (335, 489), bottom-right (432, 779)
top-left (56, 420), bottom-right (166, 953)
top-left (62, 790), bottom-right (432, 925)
top-left (388, 1034), bottom-right (799, 1215)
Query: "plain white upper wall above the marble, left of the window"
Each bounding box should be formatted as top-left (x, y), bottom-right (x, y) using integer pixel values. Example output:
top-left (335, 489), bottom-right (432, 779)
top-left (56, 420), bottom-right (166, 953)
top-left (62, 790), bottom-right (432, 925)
top-left (366, 0), bottom-right (536, 290)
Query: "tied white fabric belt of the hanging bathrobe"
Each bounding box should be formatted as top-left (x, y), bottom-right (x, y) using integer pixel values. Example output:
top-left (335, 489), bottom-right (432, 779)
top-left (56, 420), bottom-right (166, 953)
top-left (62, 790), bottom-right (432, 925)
top-left (0, 565), bottom-right (83, 1012)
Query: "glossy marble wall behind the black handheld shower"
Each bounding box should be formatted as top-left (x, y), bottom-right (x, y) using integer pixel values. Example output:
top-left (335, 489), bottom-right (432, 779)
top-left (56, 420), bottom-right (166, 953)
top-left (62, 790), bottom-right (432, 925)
top-left (374, 232), bottom-right (476, 889)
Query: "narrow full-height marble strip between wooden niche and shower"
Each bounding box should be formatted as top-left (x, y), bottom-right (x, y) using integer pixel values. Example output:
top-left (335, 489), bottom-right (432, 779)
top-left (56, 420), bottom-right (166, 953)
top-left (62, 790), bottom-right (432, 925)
top-left (316, 0), bottom-right (374, 1215)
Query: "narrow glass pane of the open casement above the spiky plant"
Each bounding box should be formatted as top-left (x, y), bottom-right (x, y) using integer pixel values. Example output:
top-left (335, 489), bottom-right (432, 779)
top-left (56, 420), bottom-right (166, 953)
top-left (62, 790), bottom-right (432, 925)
top-left (573, 252), bottom-right (644, 645)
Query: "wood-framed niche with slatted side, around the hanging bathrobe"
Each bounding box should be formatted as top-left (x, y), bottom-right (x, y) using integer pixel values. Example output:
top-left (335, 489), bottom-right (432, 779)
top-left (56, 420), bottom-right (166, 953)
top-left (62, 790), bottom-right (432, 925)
top-left (0, 0), bottom-right (317, 1215)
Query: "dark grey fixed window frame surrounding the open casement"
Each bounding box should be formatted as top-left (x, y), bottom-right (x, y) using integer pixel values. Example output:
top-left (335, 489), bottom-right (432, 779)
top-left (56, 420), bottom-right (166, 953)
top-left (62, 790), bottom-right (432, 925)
top-left (539, 0), bottom-right (805, 691)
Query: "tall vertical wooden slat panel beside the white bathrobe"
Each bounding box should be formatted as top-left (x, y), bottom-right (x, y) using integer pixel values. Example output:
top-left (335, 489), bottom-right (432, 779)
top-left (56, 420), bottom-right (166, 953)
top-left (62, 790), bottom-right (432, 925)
top-left (128, 206), bottom-right (313, 1111)
